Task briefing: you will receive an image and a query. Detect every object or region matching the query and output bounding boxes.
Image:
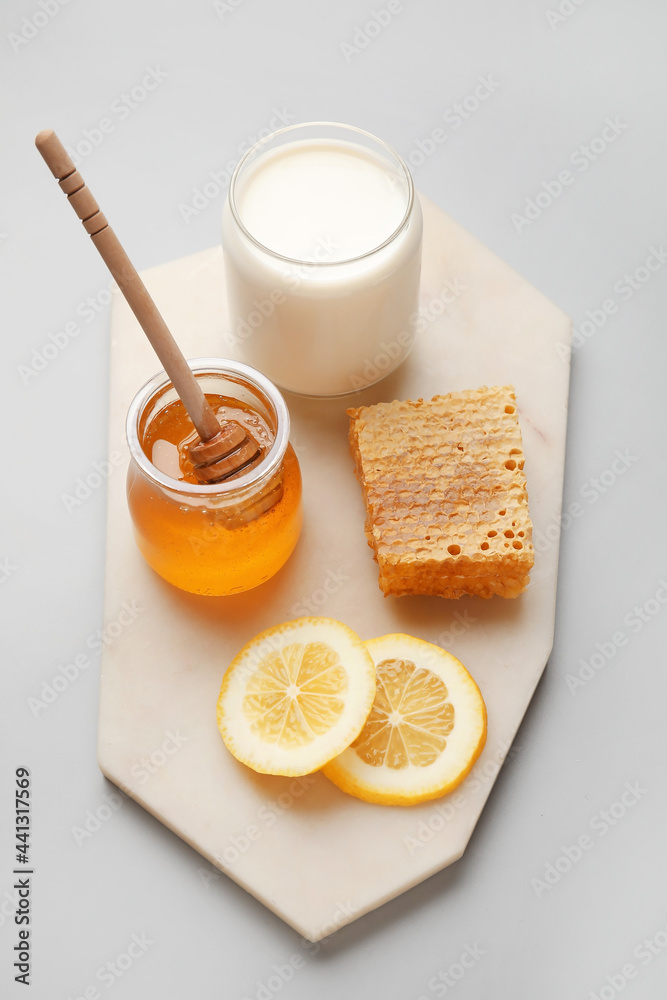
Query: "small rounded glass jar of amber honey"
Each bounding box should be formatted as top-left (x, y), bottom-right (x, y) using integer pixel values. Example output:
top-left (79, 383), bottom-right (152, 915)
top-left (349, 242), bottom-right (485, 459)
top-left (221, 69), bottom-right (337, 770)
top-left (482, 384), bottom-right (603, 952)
top-left (126, 358), bottom-right (302, 596)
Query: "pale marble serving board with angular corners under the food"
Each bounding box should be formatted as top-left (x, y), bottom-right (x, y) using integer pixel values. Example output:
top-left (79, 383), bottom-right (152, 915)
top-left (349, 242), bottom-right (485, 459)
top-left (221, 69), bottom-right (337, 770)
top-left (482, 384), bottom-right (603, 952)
top-left (99, 198), bottom-right (571, 941)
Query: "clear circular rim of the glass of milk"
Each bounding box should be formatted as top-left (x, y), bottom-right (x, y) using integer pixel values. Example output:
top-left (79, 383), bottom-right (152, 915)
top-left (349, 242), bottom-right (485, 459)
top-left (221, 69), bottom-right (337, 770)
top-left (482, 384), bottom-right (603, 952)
top-left (227, 121), bottom-right (415, 268)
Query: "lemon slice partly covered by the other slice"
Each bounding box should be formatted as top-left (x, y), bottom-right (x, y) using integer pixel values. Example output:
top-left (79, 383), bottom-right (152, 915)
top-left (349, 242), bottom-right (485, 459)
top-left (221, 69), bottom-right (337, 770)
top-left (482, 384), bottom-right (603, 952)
top-left (323, 635), bottom-right (486, 805)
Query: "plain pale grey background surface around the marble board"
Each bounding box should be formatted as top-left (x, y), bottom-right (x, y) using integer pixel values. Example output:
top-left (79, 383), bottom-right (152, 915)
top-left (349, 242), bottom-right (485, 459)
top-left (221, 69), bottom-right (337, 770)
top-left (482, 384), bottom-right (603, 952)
top-left (0, 0), bottom-right (667, 1000)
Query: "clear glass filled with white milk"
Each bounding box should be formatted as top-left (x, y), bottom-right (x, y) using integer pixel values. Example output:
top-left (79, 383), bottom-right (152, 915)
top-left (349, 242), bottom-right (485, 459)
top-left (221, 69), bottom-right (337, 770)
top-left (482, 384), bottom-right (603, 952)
top-left (222, 122), bottom-right (422, 396)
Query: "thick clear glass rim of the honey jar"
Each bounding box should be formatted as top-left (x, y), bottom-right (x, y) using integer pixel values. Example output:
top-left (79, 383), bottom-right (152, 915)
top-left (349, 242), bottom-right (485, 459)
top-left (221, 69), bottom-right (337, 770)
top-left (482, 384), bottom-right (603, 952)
top-left (125, 358), bottom-right (290, 497)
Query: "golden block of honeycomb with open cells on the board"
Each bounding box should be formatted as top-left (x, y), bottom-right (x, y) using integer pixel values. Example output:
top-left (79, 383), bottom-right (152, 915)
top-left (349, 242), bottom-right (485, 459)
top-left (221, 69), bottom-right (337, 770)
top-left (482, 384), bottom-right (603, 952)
top-left (347, 386), bottom-right (534, 598)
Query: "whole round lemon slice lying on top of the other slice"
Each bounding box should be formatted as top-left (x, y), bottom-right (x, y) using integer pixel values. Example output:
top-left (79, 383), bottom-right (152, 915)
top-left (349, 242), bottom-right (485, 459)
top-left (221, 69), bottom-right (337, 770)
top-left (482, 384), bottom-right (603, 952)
top-left (218, 618), bottom-right (375, 775)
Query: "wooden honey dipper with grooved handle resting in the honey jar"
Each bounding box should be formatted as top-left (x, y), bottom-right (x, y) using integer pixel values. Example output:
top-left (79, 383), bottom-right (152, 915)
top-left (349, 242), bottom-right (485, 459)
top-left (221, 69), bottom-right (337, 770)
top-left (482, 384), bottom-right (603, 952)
top-left (35, 129), bottom-right (263, 483)
